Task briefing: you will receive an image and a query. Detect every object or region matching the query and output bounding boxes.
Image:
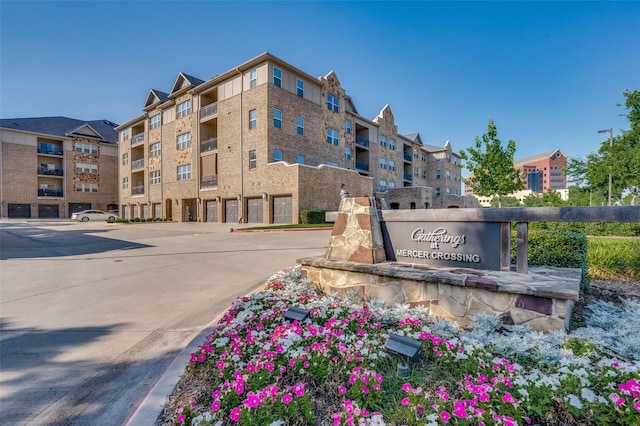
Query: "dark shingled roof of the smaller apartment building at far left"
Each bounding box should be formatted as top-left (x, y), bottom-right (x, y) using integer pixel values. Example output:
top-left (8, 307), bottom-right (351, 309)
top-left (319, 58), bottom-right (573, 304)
top-left (0, 117), bottom-right (118, 144)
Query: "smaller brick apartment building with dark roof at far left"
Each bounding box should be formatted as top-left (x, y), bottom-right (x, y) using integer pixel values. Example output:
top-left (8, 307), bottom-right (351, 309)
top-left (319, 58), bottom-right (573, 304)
top-left (0, 117), bottom-right (118, 218)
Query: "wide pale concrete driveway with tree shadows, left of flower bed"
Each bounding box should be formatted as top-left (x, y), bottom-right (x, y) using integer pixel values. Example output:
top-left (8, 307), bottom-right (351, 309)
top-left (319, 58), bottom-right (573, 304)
top-left (0, 221), bottom-right (330, 425)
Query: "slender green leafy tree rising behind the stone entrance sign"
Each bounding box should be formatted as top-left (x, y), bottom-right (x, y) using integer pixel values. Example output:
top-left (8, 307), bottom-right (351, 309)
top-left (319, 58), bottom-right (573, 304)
top-left (460, 119), bottom-right (524, 207)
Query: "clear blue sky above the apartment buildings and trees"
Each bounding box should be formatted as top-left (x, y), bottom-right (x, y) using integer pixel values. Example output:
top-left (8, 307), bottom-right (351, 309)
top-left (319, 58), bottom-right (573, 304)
top-left (0, 0), bottom-right (640, 168)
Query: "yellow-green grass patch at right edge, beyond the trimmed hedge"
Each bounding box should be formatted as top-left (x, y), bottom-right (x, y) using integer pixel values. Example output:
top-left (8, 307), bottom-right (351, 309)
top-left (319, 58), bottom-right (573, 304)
top-left (587, 237), bottom-right (640, 281)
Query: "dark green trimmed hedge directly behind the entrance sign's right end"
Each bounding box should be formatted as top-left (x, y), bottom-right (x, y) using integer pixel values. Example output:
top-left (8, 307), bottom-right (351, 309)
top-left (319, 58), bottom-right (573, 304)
top-left (511, 229), bottom-right (590, 290)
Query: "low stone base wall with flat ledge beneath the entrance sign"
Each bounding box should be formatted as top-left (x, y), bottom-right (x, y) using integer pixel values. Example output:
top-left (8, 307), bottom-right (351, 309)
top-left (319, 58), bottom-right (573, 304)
top-left (299, 258), bottom-right (581, 331)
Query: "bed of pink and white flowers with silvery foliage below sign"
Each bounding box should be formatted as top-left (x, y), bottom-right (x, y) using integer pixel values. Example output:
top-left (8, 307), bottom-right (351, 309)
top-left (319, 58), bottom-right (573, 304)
top-left (165, 267), bottom-right (640, 425)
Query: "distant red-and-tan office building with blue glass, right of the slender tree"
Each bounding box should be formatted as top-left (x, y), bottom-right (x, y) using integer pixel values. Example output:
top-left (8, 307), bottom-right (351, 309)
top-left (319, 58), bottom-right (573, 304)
top-left (464, 149), bottom-right (567, 201)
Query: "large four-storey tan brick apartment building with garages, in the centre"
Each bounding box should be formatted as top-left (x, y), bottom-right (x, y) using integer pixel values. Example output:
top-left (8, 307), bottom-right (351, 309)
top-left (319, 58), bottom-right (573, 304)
top-left (116, 53), bottom-right (460, 223)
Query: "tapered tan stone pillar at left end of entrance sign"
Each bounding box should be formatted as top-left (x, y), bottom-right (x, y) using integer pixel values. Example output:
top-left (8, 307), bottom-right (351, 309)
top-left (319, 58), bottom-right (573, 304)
top-left (326, 197), bottom-right (387, 264)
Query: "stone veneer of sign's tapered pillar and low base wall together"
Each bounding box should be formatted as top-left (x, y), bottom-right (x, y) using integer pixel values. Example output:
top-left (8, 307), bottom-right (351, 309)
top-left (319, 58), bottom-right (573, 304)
top-left (298, 197), bottom-right (581, 331)
